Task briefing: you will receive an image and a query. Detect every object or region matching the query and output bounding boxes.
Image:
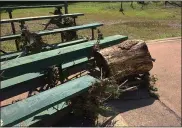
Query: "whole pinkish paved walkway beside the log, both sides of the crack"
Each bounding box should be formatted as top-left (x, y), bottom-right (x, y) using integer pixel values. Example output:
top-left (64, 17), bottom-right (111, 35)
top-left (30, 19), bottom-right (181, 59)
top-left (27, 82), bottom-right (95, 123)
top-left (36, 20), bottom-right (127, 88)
top-left (106, 38), bottom-right (181, 126)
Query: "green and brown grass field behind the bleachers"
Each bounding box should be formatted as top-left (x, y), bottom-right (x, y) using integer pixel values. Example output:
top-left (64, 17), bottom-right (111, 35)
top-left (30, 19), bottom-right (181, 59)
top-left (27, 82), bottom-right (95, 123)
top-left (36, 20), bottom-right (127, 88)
top-left (1, 2), bottom-right (181, 51)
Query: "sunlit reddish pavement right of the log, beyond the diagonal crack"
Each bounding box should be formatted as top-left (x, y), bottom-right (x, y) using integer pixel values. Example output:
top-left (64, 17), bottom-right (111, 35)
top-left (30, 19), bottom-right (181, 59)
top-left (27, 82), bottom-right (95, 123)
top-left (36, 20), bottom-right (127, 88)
top-left (148, 38), bottom-right (181, 118)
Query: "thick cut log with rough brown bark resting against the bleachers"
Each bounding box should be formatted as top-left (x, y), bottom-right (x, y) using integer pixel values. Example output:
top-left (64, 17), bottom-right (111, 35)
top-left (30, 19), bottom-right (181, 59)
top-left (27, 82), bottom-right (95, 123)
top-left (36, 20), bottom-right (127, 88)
top-left (94, 40), bottom-right (153, 78)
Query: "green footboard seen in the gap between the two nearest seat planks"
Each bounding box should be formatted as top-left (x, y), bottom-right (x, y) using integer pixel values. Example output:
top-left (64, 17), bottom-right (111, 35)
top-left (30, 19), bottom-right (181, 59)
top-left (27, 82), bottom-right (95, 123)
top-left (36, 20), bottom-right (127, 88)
top-left (0, 57), bottom-right (93, 89)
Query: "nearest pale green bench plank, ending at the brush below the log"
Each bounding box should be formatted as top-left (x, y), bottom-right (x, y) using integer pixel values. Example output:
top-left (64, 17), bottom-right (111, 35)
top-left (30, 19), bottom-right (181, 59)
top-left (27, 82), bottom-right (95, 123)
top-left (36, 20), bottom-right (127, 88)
top-left (1, 75), bottom-right (97, 126)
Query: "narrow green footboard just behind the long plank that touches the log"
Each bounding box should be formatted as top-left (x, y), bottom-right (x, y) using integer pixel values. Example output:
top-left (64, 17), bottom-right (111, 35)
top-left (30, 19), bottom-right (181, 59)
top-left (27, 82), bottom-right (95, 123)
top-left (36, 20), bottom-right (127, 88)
top-left (0, 39), bottom-right (88, 62)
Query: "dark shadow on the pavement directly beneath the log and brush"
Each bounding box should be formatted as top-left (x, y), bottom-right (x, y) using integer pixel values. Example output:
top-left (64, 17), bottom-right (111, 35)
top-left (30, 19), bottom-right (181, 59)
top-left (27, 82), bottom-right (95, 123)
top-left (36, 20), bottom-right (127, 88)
top-left (97, 88), bottom-right (156, 127)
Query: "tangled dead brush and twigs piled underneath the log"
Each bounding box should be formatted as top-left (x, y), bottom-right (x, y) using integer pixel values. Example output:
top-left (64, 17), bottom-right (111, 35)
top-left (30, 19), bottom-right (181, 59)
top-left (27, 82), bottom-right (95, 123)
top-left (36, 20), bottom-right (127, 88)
top-left (67, 73), bottom-right (159, 125)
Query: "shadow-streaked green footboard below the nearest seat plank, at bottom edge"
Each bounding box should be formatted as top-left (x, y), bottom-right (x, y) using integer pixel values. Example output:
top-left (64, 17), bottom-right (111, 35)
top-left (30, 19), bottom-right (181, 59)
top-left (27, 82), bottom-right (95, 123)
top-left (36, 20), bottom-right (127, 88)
top-left (14, 102), bottom-right (68, 127)
